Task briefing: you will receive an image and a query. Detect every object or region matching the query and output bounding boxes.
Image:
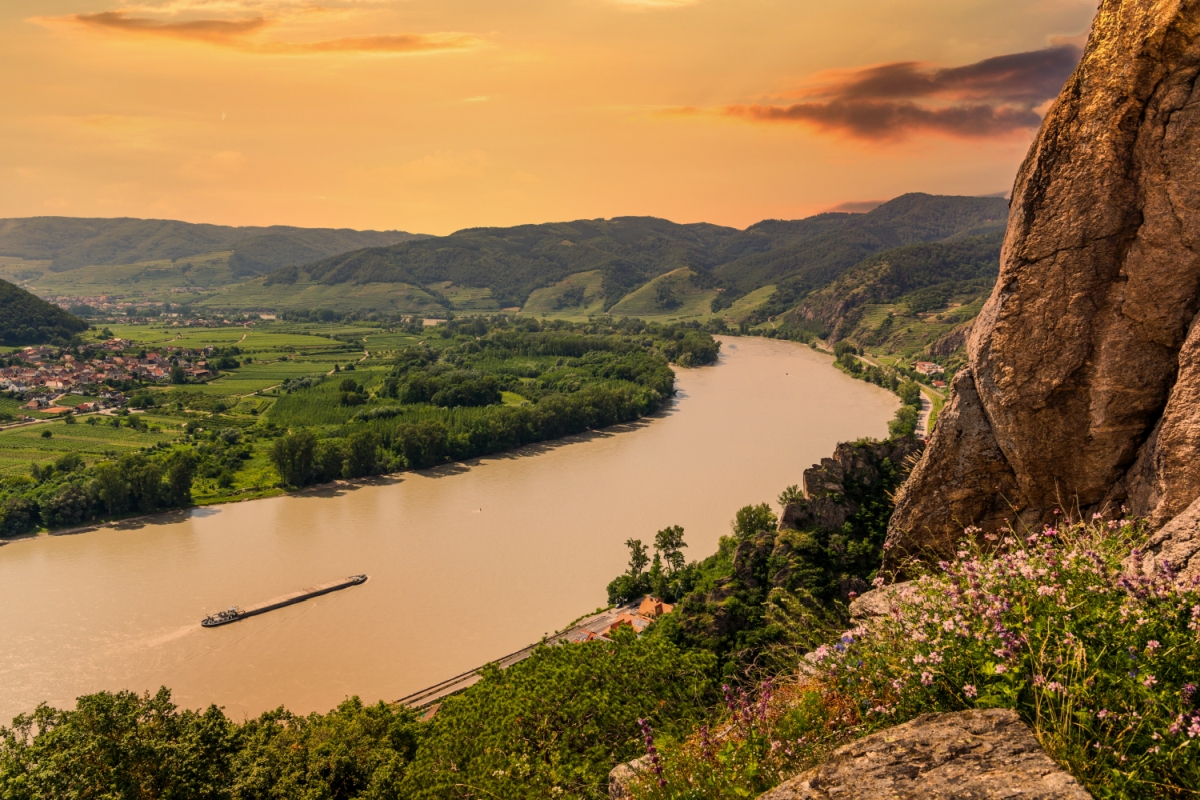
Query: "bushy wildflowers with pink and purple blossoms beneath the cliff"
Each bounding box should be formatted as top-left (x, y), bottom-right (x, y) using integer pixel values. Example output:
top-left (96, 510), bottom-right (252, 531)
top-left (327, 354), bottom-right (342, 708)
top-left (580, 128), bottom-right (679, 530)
top-left (636, 519), bottom-right (1200, 799)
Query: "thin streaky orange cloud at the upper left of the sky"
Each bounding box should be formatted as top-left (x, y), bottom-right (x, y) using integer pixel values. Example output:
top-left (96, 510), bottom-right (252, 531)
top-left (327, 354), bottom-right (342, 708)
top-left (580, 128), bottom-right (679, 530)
top-left (41, 11), bottom-right (481, 55)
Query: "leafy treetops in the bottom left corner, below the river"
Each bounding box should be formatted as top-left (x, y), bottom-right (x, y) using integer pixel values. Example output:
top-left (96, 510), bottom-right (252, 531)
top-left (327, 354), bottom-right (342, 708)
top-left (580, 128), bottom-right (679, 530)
top-left (0, 688), bottom-right (420, 800)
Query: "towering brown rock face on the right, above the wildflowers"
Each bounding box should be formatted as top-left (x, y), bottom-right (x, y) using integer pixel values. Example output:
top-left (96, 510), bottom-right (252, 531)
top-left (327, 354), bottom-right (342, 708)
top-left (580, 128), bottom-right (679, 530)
top-left (887, 0), bottom-right (1200, 567)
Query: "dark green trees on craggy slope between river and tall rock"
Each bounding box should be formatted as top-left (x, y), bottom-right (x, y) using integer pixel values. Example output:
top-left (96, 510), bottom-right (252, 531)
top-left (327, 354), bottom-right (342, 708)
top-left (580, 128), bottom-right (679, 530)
top-left (648, 440), bottom-right (913, 679)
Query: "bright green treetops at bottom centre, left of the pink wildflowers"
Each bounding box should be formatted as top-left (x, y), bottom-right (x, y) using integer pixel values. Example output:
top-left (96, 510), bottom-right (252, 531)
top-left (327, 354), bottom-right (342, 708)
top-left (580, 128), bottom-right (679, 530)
top-left (404, 631), bottom-right (715, 799)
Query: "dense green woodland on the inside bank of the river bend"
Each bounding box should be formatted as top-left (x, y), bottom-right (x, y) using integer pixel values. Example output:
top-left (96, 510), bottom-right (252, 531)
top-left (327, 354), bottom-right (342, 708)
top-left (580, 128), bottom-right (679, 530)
top-left (269, 318), bottom-right (718, 486)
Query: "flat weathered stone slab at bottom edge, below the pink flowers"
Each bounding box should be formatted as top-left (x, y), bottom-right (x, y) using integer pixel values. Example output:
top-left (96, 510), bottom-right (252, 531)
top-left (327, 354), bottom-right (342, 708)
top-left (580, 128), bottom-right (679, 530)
top-left (758, 709), bottom-right (1092, 800)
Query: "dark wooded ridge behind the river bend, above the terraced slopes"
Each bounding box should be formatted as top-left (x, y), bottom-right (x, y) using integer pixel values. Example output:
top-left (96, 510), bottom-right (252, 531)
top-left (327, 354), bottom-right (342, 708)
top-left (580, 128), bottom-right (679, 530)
top-left (268, 194), bottom-right (1008, 311)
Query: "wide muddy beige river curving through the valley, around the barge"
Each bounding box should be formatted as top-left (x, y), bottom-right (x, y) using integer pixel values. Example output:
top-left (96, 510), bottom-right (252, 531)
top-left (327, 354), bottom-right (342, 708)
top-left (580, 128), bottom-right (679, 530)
top-left (0, 338), bottom-right (898, 723)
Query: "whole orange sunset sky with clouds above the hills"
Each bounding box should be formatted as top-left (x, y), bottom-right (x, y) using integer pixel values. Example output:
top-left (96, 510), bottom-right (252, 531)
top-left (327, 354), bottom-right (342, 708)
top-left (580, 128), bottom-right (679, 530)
top-left (0, 0), bottom-right (1096, 234)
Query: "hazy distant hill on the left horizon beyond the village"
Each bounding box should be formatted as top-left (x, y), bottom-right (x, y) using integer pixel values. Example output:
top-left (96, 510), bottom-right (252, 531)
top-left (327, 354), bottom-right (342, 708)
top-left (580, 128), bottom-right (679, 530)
top-left (0, 217), bottom-right (414, 276)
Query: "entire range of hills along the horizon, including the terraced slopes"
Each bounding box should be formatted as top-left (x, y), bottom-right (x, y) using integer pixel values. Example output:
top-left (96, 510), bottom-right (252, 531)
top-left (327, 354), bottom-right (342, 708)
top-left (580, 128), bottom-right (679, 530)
top-left (0, 193), bottom-right (1008, 364)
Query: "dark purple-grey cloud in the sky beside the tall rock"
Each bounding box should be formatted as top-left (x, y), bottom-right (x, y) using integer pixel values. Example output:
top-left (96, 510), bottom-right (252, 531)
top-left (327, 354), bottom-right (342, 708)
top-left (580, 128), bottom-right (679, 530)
top-left (720, 42), bottom-right (1081, 139)
